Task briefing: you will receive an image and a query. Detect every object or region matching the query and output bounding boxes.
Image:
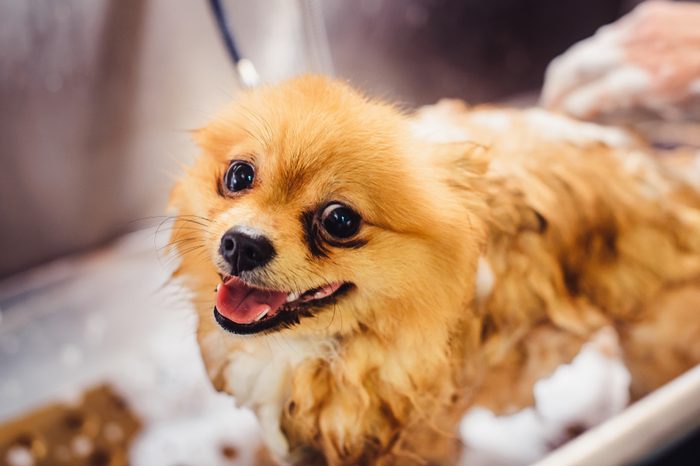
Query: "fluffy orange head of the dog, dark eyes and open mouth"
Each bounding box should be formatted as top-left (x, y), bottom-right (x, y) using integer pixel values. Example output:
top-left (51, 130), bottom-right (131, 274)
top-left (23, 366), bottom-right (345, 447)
top-left (171, 77), bottom-right (486, 335)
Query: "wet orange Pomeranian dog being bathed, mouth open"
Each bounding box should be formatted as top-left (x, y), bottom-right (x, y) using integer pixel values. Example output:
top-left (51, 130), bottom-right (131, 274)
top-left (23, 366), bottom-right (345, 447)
top-left (171, 76), bottom-right (700, 465)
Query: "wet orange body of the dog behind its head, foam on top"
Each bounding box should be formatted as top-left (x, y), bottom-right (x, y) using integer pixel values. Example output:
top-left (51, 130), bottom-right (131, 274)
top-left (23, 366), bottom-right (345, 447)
top-left (416, 101), bottom-right (700, 407)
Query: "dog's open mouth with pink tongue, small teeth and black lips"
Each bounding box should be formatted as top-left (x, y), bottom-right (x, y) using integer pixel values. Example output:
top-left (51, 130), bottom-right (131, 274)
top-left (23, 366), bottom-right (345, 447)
top-left (214, 277), bottom-right (352, 334)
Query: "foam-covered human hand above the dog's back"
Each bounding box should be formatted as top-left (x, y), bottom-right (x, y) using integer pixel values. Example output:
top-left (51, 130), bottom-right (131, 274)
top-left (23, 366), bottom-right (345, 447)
top-left (542, 1), bottom-right (700, 122)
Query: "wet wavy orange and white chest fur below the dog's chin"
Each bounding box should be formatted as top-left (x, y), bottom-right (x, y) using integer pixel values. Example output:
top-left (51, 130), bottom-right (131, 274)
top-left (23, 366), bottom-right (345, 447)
top-left (213, 266), bottom-right (479, 464)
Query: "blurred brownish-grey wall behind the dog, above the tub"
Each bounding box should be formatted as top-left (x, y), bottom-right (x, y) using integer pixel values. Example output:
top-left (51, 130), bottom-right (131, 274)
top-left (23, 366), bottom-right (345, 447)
top-left (0, 0), bottom-right (652, 277)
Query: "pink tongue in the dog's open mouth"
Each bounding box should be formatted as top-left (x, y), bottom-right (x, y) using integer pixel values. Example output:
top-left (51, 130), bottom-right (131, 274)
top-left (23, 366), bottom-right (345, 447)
top-left (216, 277), bottom-right (287, 324)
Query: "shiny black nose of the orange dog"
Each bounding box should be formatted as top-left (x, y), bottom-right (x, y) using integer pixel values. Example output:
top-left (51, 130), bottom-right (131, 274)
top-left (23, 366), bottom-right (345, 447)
top-left (219, 229), bottom-right (275, 275)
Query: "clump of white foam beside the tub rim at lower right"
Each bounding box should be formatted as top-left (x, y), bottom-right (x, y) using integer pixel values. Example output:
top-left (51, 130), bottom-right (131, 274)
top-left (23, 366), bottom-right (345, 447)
top-left (459, 328), bottom-right (630, 466)
